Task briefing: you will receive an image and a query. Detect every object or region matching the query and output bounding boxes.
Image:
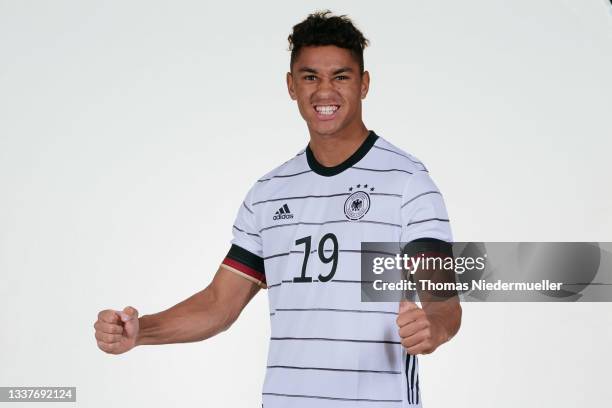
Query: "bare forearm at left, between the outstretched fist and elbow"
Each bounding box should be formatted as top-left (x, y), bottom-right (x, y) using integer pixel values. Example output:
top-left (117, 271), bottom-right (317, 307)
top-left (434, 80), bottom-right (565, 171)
top-left (136, 288), bottom-right (235, 345)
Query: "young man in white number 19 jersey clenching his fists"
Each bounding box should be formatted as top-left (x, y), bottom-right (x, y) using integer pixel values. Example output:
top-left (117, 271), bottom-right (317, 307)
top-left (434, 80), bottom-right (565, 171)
top-left (94, 12), bottom-right (461, 408)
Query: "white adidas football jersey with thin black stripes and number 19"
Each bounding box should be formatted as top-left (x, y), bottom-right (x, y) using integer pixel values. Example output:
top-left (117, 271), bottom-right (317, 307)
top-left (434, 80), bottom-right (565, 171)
top-left (222, 131), bottom-right (452, 408)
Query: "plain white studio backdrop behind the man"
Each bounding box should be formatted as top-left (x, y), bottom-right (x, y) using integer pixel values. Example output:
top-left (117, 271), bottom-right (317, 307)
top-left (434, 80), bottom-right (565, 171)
top-left (0, 0), bottom-right (612, 408)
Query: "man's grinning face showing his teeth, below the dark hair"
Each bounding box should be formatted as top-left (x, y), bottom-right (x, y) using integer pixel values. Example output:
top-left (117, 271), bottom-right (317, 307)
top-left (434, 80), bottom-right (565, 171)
top-left (287, 45), bottom-right (370, 135)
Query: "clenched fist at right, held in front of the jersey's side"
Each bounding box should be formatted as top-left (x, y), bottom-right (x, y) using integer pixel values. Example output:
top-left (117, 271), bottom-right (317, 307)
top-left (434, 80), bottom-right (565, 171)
top-left (396, 301), bottom-right (445, 355)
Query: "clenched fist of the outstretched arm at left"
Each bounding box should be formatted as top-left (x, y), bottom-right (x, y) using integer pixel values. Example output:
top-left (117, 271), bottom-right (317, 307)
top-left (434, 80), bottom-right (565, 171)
top-left (94, 306), bottom-right (138, 354)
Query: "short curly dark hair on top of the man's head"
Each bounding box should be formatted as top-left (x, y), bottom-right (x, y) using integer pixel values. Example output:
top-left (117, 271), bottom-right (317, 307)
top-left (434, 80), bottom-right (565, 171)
top-left (287, 10), bottom-right (370, 73)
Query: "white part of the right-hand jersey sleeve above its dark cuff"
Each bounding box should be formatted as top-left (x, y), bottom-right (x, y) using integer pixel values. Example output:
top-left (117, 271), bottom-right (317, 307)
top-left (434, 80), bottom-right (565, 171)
top-left (400, 172), bottom-right (453, 243)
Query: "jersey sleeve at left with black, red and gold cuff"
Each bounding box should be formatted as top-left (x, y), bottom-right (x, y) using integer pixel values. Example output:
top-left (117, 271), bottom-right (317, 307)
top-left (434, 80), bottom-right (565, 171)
top-left (221, 188), bottom-right (266, 288)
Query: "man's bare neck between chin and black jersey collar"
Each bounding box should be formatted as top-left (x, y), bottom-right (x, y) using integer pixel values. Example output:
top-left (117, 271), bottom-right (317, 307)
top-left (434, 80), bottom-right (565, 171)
top-left (308, 121), bottom-right (368, 167)
